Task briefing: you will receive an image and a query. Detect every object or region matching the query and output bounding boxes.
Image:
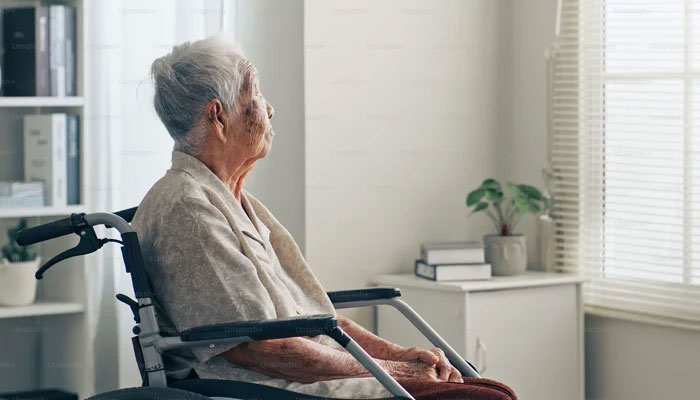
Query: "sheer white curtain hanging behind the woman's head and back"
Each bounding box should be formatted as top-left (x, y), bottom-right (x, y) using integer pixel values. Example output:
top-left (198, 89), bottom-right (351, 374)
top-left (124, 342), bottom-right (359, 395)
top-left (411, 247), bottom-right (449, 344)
top-left (84, 0), bottom-right (237, 392)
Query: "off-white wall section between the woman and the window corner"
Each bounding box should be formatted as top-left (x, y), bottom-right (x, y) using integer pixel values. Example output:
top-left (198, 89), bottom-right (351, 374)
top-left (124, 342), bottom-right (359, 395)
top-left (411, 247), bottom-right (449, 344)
top-left (304, 0), bottom-right (510, 327)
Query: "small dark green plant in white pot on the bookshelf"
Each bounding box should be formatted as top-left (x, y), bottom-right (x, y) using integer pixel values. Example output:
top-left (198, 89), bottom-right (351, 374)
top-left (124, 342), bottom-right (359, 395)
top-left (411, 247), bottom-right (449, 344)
top-left (0, 218), bottom-right (41, 306)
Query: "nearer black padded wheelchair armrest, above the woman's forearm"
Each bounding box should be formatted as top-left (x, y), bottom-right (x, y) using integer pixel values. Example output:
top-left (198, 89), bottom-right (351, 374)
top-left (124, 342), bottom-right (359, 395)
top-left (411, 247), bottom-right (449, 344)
top-left (180, 314), bottom-right (338, 342)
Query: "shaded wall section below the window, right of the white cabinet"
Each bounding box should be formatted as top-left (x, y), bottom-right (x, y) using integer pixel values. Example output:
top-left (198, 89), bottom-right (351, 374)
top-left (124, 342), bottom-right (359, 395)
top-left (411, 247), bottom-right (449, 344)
top-left (585, 315), bottom-right (700, 400)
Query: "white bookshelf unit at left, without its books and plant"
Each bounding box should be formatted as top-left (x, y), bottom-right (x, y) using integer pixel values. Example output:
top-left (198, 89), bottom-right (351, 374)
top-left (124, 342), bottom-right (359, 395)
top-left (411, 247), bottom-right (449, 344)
top-left (0, 0), bottom-right (94, 398)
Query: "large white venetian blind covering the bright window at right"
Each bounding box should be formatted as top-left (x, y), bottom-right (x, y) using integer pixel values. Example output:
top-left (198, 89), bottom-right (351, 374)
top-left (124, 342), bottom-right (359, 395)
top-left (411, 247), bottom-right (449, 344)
top-left (568, 0), bottom-right (700, 326)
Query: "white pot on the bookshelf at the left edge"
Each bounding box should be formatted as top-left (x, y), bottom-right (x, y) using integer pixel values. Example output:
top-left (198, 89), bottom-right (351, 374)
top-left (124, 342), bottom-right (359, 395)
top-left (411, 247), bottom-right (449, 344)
top-left (0, 257), bottom-right (41, 306)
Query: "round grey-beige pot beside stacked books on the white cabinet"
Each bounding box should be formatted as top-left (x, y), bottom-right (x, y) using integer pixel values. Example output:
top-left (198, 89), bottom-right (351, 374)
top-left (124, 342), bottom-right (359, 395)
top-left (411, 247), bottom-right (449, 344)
top-left (484, 235), bottom-right (527, 275)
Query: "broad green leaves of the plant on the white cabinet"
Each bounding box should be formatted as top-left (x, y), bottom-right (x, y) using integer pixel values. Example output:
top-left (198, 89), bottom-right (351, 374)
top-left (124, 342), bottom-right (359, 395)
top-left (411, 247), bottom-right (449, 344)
top-left (467, 178), bottom-right (549, 236)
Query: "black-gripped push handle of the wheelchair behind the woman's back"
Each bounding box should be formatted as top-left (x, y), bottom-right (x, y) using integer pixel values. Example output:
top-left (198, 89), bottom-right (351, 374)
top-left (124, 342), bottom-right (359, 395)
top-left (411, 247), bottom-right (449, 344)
top-left (17, 207), bottom-right (136, 246)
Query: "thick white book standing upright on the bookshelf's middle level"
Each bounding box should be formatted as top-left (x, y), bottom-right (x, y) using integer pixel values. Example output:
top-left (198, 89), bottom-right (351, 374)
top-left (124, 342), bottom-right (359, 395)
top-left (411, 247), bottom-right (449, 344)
top-left (24, 113), bottom-right (68, 206)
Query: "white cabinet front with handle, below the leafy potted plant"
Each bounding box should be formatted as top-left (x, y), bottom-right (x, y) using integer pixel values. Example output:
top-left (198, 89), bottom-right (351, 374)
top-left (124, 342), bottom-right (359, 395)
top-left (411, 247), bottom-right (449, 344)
top-left (467, 285), bottom-right (582, 400)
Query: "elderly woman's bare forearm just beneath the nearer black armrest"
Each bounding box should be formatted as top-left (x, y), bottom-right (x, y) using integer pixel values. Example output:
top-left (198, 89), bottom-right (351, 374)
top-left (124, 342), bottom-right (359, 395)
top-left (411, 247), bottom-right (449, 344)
top-left (223, 337), bottom-right (378, 383)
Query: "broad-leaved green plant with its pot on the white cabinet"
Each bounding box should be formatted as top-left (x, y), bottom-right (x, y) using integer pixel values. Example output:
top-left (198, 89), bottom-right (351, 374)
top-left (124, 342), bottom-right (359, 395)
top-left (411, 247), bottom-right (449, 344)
top-left (467, 178), bottom-right (549, 275)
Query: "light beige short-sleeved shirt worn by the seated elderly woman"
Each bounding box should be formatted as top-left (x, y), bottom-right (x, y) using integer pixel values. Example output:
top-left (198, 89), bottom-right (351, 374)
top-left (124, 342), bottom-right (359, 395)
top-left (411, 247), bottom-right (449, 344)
top-left (132, 151), bottom-right (391, 398)
